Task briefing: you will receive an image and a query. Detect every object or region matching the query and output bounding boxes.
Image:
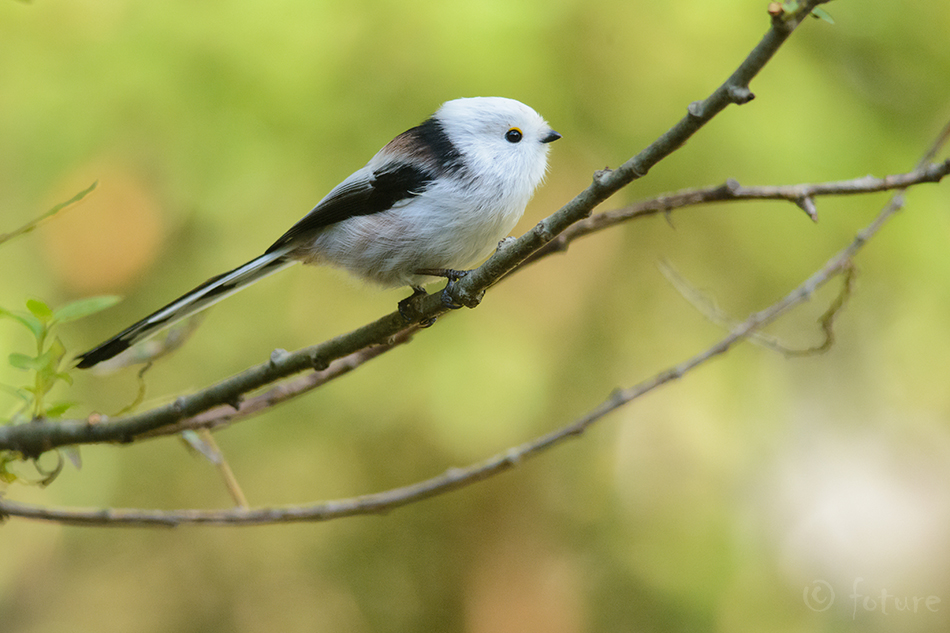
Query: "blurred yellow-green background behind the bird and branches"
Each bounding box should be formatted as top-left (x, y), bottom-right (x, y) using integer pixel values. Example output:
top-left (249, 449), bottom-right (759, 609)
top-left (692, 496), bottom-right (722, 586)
top-left (0, 0), bottom-right (950, 633)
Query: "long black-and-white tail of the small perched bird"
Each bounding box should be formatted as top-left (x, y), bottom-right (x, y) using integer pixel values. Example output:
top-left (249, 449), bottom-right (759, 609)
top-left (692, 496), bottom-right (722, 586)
top-left (76, 251), bottom-right (295, 369)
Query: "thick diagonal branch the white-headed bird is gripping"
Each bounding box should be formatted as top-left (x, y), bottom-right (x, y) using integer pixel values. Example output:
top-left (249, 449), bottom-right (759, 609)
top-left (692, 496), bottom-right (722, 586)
top-left (0, 0), bottom-right (827, 457)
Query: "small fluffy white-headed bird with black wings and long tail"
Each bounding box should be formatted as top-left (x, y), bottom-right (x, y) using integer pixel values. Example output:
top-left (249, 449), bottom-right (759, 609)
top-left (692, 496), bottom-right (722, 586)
top-left (76, 97), bottom-right (561, 369)
